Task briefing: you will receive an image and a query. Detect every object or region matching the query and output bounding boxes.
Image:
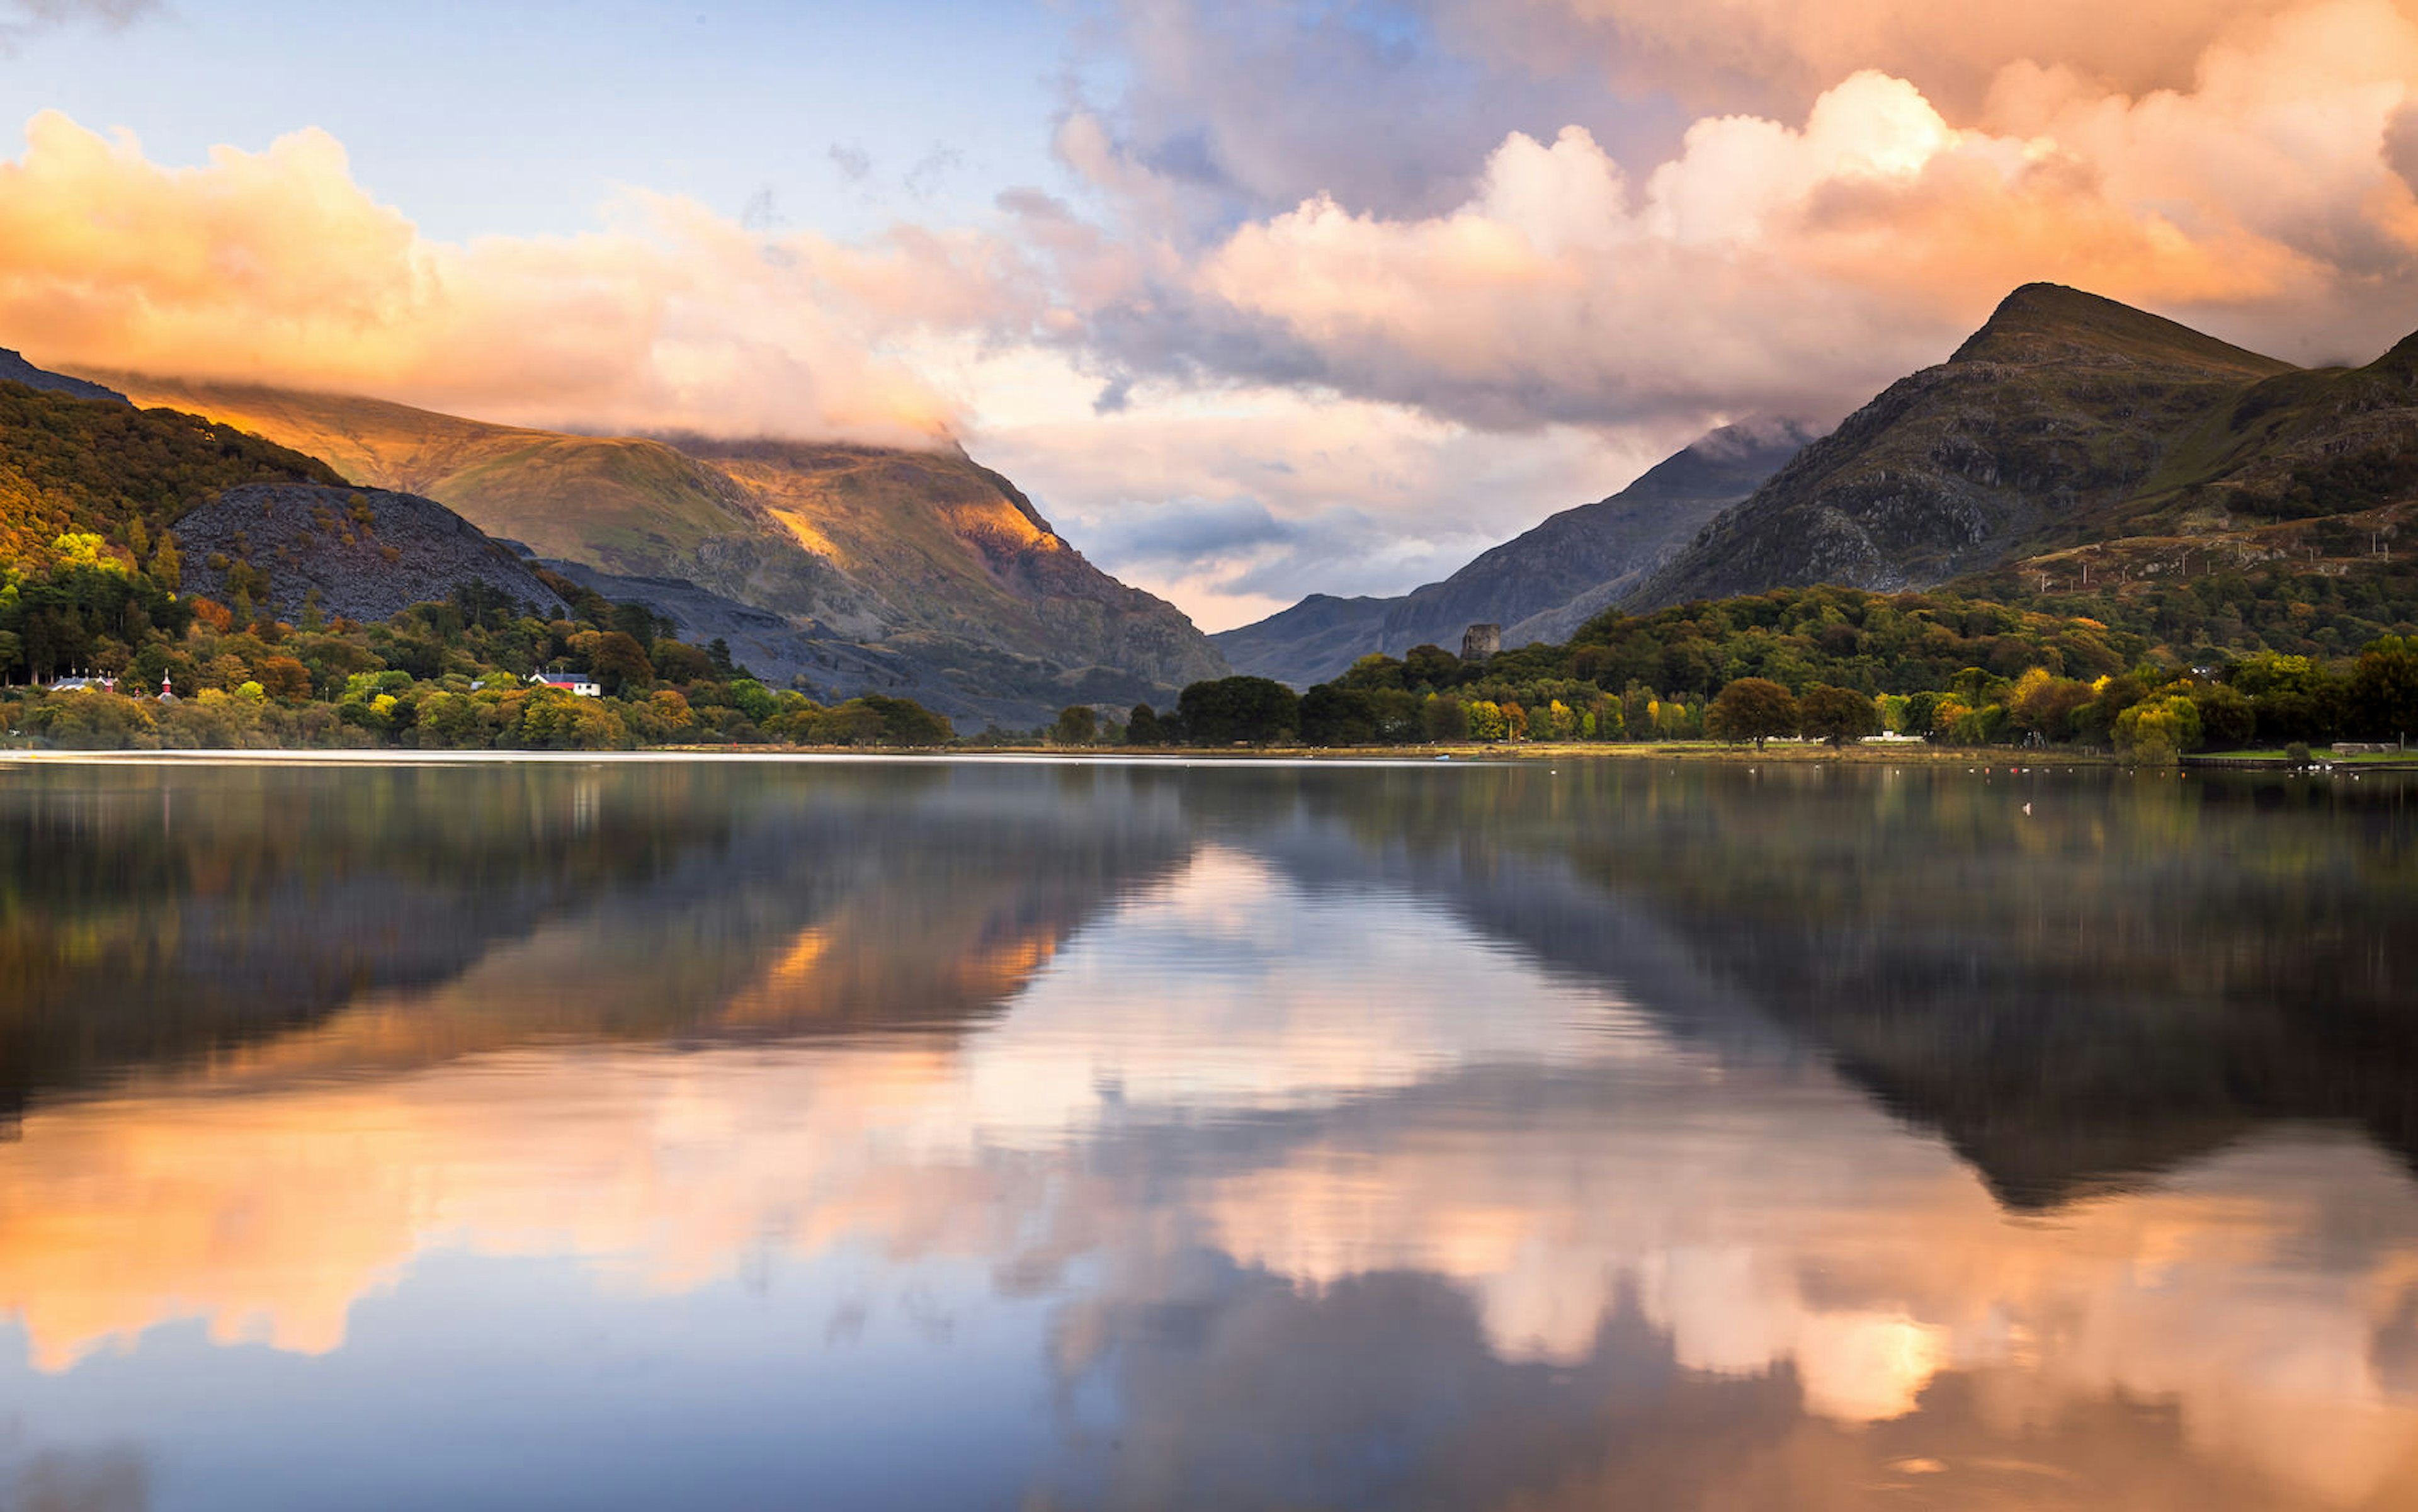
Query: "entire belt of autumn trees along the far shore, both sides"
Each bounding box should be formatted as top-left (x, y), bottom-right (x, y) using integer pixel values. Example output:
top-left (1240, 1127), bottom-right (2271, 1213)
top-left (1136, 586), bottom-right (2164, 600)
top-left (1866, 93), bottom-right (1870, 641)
top-left (19, 532), bottom-right (2418, 759)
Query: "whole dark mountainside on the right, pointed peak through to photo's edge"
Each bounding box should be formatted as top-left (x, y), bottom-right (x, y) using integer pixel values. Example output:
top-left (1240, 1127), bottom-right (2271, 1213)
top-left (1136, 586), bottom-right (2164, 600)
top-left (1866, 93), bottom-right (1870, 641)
top-left (1623, 283), bottom-right (2418, 607)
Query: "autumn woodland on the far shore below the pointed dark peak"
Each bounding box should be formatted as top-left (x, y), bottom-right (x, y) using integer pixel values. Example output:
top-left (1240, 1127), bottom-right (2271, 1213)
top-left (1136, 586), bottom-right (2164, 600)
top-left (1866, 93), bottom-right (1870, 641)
top-left (1081, 588), bottom-right (2418, 759)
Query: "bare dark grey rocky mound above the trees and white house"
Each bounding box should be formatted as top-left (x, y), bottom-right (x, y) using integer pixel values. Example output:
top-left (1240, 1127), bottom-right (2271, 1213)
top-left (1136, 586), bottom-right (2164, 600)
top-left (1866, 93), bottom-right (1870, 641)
top-left (176, 484), bottom-right (570, 624)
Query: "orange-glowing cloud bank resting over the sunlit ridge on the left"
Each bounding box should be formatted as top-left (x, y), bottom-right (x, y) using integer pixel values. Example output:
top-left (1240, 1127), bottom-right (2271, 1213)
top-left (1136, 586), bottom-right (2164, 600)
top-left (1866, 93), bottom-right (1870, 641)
top-left (0, 111), bottom-right (1028, 440)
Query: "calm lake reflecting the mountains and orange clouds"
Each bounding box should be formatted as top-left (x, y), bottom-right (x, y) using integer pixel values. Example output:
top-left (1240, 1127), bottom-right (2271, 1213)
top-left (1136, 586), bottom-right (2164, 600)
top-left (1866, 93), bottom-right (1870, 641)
top-left (0, 759), bottom-right (2418, 1512)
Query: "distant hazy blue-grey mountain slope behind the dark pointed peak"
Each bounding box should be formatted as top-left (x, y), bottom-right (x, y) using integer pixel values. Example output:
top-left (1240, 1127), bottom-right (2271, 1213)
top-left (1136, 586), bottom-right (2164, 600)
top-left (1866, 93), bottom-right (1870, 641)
top-left (1209, 426), bottom-right (1811, 685)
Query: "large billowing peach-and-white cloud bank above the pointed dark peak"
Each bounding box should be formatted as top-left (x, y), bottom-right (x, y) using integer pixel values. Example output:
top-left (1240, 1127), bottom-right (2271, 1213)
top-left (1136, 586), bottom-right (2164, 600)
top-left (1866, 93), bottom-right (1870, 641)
top-left (1062, 0), bottom-right (2418, 443)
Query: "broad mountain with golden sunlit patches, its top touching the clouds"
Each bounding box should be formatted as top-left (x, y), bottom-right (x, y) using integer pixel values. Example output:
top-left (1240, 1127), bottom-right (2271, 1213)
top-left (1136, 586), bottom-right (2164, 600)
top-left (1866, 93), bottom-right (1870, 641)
top-left (80, 373), bottom-right (1226, 725)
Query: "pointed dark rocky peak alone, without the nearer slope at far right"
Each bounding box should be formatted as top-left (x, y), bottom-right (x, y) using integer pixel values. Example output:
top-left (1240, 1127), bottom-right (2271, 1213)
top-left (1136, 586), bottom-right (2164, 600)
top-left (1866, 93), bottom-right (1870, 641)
top-left (1625, 283), bottom-right (2302, 607)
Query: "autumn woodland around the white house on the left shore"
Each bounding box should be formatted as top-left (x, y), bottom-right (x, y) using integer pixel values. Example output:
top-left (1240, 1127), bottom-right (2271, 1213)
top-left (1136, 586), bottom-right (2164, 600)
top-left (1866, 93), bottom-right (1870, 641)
top-left (0, 544), bottom-right (953, 750)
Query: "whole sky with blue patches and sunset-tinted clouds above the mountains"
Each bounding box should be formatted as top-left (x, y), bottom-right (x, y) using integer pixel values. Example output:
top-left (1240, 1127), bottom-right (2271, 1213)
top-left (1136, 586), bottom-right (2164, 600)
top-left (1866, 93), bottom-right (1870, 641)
top-left (0, 0), bottom-right (2418, 629)
